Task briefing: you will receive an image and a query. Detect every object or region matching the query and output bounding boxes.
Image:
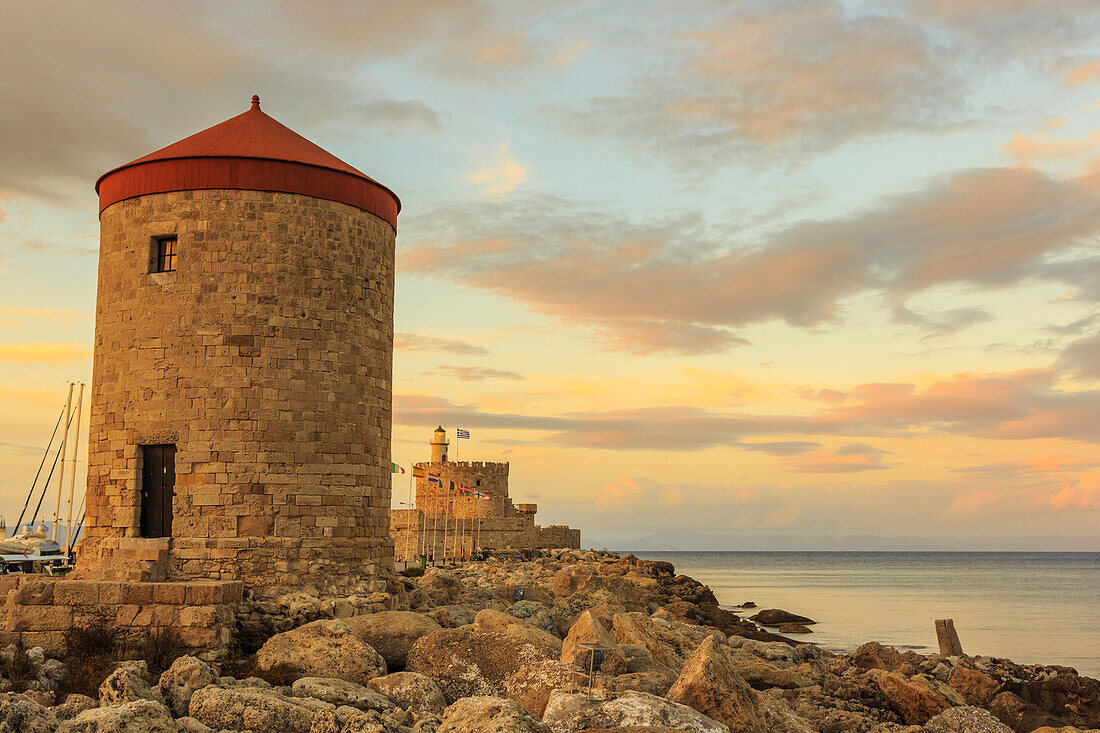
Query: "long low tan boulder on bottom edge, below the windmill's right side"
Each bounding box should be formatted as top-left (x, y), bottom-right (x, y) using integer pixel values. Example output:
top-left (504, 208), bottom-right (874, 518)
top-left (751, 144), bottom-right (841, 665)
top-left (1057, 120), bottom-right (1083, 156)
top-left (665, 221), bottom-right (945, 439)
top-left (190, 686), bottom-right (334, 733)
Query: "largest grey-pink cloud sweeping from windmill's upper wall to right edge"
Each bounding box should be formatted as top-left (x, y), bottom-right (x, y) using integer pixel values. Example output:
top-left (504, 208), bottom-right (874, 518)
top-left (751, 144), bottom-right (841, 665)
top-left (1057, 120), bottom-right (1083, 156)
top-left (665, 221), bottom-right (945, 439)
top-left (400, 161), bottom-right (1100, 353)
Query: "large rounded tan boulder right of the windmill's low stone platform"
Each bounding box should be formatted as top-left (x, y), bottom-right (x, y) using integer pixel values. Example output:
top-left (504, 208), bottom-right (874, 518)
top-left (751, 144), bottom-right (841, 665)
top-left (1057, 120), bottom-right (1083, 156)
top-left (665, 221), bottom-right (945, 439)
top-left (256, 620), bottom-right (386, 685)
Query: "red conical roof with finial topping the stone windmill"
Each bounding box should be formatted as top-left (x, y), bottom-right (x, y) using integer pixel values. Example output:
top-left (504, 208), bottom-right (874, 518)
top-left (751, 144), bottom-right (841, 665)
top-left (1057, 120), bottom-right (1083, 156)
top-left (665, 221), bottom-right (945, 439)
top-left (96, 96), bottom-right (400, 230)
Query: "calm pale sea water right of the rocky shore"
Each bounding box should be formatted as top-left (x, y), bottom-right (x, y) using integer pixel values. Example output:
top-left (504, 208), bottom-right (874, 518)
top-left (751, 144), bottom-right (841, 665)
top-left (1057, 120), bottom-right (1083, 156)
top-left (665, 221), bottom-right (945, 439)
top-left (636, 553), bottom-right (1100, 678)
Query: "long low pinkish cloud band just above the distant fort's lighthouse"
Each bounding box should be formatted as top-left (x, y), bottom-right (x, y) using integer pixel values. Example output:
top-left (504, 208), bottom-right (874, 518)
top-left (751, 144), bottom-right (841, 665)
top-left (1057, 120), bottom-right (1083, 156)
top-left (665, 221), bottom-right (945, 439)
top-left (394, 369), bottom-right (1100, 449)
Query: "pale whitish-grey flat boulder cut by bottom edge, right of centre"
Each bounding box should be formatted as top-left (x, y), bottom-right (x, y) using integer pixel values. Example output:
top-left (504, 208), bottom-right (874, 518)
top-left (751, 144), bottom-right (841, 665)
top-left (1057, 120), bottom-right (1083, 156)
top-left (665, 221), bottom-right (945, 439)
top-left (542, 690), bottom-right (729, 733)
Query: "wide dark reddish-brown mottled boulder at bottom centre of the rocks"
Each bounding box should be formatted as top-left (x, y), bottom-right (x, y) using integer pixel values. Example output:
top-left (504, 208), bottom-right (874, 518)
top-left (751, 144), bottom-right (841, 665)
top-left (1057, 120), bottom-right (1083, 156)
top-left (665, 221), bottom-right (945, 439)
top-left (407, 628), bottom-right (558, 712)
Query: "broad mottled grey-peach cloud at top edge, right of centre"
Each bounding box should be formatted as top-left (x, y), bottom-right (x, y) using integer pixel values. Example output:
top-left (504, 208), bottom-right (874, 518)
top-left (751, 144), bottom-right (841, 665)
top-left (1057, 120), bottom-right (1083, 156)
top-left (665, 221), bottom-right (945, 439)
top-left (545, 0), bottom-right (964, 162)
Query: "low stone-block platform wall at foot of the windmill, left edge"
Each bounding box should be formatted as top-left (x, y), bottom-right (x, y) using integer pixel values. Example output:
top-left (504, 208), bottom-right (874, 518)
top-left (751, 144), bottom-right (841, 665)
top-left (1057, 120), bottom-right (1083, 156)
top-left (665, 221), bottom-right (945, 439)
top-left (0, 576), bottom-right (244, 657)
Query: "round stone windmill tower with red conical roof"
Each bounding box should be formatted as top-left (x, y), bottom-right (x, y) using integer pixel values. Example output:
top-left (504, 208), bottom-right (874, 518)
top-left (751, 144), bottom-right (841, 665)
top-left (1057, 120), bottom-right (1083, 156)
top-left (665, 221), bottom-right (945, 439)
top-left (74, 97), bottom-right (400, 595)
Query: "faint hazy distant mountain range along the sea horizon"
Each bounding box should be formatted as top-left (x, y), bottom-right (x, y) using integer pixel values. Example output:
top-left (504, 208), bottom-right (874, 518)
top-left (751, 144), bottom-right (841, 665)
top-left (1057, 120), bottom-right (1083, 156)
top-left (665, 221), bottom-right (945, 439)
top-left (584, 530), bottom-right (1100, 553)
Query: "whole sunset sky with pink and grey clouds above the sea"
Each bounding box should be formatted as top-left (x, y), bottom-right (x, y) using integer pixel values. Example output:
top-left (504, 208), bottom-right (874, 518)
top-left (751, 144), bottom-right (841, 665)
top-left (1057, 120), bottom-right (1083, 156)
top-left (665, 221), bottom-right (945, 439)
top-left (0, 0), bottom-right (1100, 543)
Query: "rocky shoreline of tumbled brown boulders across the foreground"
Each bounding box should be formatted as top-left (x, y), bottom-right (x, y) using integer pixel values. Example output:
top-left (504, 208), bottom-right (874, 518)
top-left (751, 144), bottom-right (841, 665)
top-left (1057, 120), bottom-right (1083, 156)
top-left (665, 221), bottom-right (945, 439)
top-left (0, 550), bottom-right (1100, 733)
